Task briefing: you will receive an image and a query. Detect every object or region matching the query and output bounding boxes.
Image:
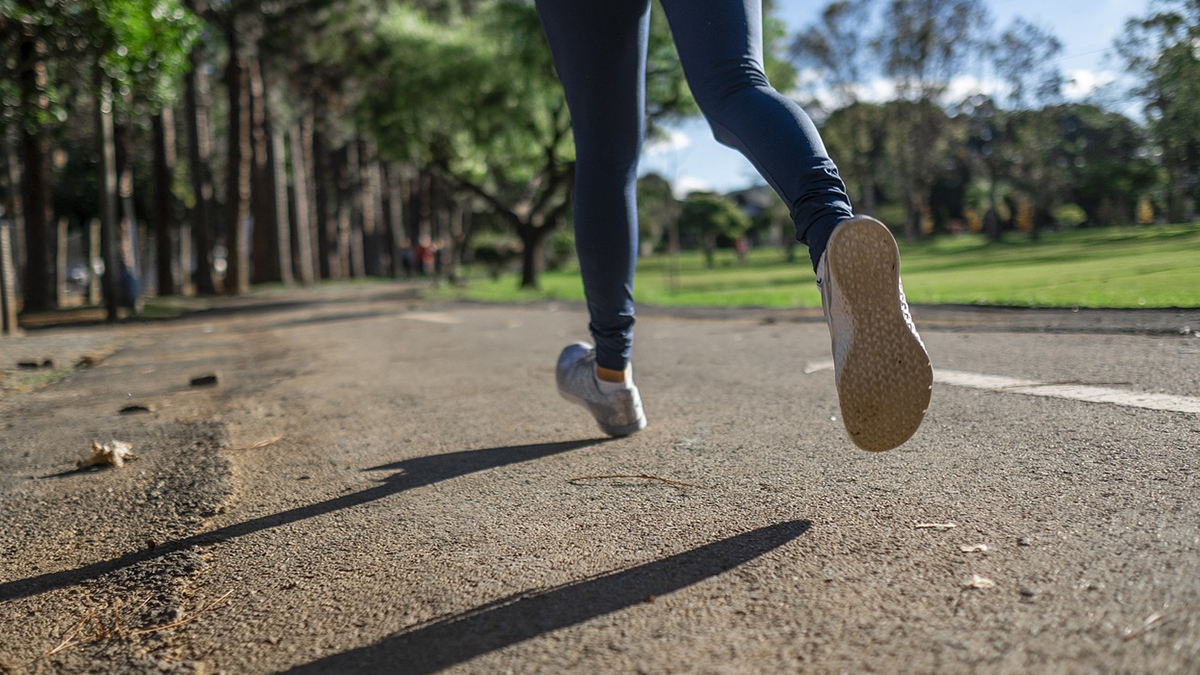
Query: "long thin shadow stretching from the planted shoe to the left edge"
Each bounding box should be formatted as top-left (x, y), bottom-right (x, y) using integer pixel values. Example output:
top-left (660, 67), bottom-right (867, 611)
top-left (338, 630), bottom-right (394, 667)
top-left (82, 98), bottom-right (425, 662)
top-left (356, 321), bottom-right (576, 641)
top-left (0, 438), bottom-right (610, 602)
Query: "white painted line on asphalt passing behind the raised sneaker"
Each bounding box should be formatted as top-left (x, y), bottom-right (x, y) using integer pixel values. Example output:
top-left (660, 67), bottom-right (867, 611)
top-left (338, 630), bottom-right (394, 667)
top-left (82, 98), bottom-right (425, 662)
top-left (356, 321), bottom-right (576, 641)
top-left (804, 360), bottom-right (1200, 413)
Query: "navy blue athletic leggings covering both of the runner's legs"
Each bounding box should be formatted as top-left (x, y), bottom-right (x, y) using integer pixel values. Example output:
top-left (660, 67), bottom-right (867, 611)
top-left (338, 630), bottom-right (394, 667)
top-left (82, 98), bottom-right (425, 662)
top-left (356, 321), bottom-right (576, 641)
top-left (536, 0), bottom-right (852, 370)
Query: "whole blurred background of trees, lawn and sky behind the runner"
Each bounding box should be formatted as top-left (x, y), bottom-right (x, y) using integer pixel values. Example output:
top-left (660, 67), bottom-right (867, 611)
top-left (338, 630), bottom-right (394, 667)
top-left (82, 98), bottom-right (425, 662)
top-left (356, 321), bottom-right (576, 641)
top-left (0, 0), bottom-right (1200, 329)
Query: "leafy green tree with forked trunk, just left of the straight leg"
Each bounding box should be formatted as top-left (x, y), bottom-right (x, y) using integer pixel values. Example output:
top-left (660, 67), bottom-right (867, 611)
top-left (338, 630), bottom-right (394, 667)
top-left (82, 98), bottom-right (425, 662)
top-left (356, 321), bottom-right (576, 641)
top-left (364, 2), bottom-right (575, 287)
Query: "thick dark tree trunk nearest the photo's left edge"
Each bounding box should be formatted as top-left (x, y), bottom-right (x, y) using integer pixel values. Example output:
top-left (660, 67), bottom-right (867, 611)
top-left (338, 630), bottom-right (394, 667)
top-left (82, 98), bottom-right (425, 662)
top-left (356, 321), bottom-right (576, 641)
top-left (19, 37), bottom-right (55, 311)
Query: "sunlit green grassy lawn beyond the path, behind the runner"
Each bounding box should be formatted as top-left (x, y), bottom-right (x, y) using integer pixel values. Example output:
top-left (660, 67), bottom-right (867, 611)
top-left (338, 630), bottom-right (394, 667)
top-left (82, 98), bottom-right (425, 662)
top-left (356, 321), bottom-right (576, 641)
top-left (432, 225), bottom-right (1200, 307)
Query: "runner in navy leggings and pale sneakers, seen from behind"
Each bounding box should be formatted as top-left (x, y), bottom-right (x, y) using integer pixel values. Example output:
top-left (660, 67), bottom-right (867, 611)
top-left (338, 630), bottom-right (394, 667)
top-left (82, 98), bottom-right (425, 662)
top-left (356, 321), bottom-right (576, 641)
top-left (536, 0), bottom-right (932, 450)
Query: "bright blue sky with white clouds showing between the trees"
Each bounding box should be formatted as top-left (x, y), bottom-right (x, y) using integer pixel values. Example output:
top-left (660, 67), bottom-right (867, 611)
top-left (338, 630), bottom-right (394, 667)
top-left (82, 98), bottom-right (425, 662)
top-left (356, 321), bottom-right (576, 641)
top-left (638, 0), bottom-right (1150, 197)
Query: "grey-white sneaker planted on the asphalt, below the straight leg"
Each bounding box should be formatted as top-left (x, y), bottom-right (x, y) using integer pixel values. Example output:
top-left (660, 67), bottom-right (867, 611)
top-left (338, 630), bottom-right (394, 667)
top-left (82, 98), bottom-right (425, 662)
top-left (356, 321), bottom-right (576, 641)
top-left (556, 342), bottom-right (646, 436)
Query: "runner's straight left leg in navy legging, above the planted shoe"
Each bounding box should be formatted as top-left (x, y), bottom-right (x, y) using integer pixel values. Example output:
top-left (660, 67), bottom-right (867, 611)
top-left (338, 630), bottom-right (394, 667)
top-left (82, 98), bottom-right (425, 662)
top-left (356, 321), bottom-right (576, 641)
top-left (538, 0), bottom-right (650, 371)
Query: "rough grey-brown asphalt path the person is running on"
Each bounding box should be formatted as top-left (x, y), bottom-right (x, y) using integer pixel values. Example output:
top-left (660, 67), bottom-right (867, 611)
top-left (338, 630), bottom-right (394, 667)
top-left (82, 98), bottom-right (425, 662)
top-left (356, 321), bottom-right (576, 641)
top-left (0, 281), bottom-right (1200, 674)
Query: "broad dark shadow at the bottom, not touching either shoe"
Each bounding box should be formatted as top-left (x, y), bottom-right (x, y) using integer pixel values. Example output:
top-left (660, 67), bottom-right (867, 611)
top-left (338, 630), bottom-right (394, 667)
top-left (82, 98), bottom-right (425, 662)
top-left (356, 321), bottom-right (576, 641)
top-left (287, 520), bottom-right (811, 675)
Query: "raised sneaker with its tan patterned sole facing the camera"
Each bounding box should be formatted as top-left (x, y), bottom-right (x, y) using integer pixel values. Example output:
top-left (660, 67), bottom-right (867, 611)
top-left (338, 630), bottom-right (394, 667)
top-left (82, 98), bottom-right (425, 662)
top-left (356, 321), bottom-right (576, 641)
top-left (817, 216), bottom-right (934, 450)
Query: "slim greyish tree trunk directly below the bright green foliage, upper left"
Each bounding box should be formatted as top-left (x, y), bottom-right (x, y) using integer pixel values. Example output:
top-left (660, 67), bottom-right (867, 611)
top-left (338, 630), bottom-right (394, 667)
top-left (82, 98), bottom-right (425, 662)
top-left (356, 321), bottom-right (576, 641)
top-left (95, 73), bottom-right (120, 321)
